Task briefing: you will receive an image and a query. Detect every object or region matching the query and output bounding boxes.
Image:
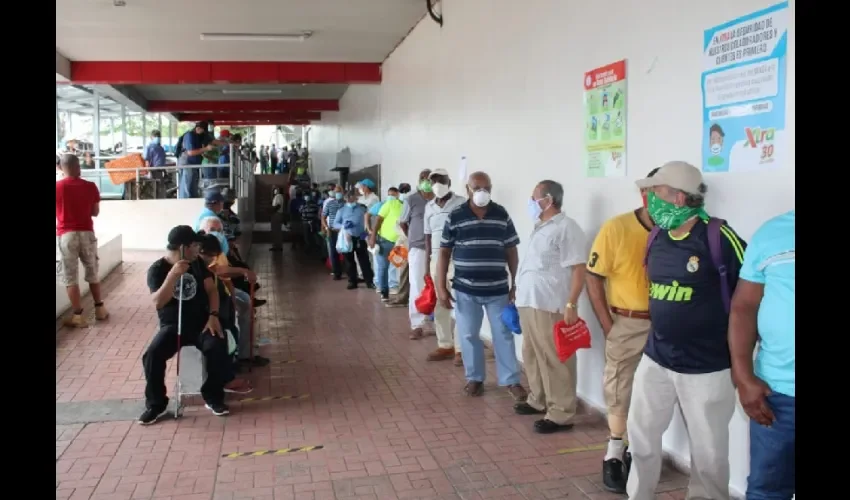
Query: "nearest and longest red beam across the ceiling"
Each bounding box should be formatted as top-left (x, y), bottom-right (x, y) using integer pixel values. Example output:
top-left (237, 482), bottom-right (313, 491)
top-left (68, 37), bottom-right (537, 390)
top-left (71, 61), bottom-right (381, 85)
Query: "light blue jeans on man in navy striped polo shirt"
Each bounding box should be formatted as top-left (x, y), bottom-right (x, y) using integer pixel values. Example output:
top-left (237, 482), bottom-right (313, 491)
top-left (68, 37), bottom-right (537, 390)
top-left (454, 290), bottom-right (520, 386)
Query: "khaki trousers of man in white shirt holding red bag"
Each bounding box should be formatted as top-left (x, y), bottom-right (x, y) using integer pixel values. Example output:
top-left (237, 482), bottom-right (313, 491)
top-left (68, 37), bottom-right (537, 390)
top-left (518, 307), bottom-right (578, 425)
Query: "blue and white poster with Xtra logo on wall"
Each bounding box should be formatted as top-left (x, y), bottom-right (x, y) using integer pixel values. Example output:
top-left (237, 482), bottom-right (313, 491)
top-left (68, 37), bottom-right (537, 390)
top-left (702, 2), bottom-right (789, 172)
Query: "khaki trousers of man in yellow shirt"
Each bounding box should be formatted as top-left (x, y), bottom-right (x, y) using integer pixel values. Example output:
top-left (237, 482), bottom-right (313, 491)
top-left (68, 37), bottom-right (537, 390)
top-left (602, 314), bottom-right (651, 421)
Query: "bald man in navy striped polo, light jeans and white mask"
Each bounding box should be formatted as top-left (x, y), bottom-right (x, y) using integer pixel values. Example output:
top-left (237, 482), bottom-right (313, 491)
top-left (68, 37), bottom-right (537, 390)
top-left (437, 172), bottom-right (528, 402)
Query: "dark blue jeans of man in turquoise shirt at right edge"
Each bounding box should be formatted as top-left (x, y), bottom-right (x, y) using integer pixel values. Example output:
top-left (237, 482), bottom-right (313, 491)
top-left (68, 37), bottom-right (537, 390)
top-left (747, 393), bottom-right (796, 500)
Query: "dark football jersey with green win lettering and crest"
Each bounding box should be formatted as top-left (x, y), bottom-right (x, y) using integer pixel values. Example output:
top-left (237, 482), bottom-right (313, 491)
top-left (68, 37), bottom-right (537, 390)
top-left (644, 222), bottom-right (747, 374)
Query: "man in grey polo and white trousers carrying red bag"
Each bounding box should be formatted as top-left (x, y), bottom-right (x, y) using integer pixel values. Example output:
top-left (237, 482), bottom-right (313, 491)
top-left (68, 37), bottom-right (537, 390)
top-left (399, 169), bottom-right (434, 340)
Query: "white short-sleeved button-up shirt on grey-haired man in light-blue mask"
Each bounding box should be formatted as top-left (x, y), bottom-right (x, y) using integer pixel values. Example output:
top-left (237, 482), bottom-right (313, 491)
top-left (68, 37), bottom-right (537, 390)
top-left (516, 212), bottom-right (587, 313)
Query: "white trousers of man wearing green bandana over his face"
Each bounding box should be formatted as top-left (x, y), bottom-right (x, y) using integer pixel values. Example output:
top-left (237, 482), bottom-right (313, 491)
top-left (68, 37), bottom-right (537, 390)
top-left (626, 355), bottom-right (736, 500)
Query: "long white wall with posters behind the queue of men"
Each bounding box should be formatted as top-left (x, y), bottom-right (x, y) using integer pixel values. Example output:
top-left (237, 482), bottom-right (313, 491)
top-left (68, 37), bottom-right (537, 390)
top-left (311, 0), bottom-right (795, 492)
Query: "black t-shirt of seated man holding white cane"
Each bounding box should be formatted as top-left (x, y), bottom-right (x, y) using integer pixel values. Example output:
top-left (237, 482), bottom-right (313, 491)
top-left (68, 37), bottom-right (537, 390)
top-left (148, 257), bottom-right (213, 327)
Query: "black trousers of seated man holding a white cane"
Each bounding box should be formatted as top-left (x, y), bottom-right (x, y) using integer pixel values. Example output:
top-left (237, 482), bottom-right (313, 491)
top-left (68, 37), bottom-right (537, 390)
top-left (142, 325), bottom-right (233, 410)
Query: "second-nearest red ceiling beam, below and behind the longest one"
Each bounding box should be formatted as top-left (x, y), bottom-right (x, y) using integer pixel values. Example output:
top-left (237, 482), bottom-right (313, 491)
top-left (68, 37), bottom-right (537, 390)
top-left (148, 99), bottom-right (339, 113)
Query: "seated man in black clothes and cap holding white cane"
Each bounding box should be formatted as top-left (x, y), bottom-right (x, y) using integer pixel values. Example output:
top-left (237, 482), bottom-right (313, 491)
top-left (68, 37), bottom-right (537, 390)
top-left (139, 226), bottom-right (230, 425)
